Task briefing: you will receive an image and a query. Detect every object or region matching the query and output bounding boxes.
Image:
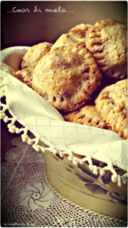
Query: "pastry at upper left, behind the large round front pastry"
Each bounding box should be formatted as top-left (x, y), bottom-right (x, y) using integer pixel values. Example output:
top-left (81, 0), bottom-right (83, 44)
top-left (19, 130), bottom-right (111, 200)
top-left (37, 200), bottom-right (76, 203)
top-left (21, 42), bottom-right (52, 70)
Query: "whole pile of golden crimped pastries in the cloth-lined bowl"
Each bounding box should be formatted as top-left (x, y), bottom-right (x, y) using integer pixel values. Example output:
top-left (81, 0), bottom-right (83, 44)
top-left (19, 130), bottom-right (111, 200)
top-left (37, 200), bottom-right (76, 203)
top-left (15, 19), bottom-right (128, 139)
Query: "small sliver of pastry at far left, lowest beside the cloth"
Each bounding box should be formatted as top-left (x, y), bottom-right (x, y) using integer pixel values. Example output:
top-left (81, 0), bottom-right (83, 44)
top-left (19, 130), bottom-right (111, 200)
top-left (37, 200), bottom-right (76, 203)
top-left (13, 68), bottom-right (32, 86)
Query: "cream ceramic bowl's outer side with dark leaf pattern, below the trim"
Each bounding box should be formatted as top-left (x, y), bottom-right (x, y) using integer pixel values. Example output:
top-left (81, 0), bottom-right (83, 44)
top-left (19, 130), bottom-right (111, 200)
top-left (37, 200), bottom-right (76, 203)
top-left (44, 152), bottom-right (127, 218)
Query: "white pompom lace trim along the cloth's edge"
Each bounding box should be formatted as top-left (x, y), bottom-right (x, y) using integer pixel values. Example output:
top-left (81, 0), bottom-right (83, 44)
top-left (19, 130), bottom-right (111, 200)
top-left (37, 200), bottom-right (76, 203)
top-left (0, 88), bottom-right (128, 187)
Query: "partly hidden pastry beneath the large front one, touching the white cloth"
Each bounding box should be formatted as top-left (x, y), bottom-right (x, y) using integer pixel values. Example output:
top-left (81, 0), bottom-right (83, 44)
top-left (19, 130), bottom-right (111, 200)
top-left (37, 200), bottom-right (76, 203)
top-left (64, 105), bottom-right (107, 128)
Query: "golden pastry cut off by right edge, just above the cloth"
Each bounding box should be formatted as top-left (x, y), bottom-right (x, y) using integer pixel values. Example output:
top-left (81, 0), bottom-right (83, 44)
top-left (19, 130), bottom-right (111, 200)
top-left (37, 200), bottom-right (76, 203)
top-left (95, 79), bottom-right (128, 139)
